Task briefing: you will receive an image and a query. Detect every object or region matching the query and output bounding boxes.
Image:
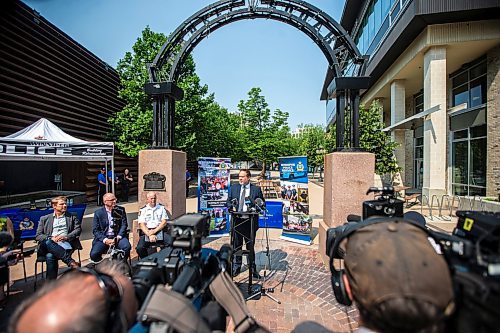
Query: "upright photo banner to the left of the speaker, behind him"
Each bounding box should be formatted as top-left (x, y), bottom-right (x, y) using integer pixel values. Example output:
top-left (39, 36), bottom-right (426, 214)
top-left (198, 157), bottom-right (231, 237)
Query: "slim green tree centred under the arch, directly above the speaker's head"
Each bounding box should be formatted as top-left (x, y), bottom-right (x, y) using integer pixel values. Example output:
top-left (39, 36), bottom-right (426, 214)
top-left (238, 88), bottom-right (290, 176)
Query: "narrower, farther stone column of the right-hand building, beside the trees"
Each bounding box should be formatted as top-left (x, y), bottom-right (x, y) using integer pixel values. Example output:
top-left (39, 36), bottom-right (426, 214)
top-left (391, 80), bottom-right (407, 185)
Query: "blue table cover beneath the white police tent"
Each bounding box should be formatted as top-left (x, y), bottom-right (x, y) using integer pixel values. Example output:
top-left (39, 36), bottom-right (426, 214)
top-left (0, 204), bottom-right (87, 240)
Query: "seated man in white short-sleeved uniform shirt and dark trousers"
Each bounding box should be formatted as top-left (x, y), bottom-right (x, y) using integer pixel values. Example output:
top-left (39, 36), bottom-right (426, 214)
top-left (136, 192), bottom-right (172, 259)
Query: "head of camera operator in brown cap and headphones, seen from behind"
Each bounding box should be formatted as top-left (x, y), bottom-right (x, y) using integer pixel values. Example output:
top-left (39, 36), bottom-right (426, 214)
top-left (327, 217), bottom-right (454, 332)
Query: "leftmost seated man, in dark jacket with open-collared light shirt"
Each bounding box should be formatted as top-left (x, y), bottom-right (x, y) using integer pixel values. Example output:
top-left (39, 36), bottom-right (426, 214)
top-left (36, 196), bottom-right (82, 279)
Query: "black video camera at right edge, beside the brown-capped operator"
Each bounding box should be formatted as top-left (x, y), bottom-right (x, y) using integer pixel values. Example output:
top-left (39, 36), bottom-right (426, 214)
top-left (433, 211), bottom-right (500, 333)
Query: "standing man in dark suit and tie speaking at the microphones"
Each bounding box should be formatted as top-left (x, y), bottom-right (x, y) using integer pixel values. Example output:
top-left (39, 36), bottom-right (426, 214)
top-left (226, 169), bottom-right (264, 279)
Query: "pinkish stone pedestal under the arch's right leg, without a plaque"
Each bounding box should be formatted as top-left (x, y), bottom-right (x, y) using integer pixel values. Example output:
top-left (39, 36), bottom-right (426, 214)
top-left (319, 152), bottom-right (375, 264)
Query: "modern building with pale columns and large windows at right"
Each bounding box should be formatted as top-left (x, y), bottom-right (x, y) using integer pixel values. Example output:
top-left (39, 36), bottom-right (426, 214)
top-left (323, 0), bottom-right (500, 198)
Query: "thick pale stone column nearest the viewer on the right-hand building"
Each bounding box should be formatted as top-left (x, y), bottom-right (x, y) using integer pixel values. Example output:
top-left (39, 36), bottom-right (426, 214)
top-left (422, 46), bottom-right (448, 201)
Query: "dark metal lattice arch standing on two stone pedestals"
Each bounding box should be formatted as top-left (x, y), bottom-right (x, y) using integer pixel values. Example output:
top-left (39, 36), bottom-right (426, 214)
top-left (145, 0), bottom-right (365, 148)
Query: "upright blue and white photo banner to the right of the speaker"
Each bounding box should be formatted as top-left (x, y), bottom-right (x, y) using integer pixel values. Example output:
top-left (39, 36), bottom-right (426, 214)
top-left (278, 156), bottom-right (312, 245)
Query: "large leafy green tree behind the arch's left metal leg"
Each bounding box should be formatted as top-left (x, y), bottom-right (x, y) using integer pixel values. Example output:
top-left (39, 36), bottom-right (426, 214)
top-left (109, 27), bottom-right (241, 160)
